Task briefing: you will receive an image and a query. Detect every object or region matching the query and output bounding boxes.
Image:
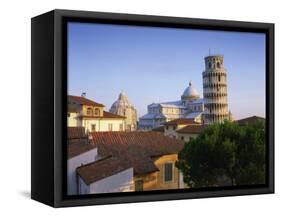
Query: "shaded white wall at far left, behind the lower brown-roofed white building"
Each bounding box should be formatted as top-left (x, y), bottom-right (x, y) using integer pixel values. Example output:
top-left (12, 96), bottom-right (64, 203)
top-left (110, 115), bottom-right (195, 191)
top-left (67, 148), bottom-right (97, 195)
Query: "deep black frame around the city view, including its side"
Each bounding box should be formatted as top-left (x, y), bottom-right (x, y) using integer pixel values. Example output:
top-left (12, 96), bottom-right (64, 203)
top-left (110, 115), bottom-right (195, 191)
top-left (31, 10), bottom-right (274, 207)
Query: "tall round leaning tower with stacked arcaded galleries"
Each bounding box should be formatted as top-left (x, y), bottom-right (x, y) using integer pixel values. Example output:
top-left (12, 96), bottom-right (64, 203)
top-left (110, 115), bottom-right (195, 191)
top-left (203, 55), bottom-right (229, 124)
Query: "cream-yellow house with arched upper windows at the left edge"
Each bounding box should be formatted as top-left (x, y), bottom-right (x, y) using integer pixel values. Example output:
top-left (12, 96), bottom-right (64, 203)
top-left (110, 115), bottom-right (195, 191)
top-left (67, 96), bottom-right (125, 132)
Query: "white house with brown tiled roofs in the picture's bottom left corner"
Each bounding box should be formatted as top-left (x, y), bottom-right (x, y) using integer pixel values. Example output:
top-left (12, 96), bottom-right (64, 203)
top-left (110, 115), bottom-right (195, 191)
top-left (67, 127), bottom-right (134, 195)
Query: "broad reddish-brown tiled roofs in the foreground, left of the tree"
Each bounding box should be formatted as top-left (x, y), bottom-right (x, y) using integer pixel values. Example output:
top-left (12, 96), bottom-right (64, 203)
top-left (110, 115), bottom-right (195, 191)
top-left (77, 132), bottom-right (184, 184)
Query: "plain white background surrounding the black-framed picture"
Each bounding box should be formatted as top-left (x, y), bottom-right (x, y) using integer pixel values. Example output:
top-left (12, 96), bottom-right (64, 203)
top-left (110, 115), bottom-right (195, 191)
top-left (0, 0), bottom-right (281, 217)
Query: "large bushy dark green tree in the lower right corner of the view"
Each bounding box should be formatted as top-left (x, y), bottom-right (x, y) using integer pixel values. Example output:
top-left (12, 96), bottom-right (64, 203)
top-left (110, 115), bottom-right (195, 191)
top-left (176, 121), bottom-right (265, 187)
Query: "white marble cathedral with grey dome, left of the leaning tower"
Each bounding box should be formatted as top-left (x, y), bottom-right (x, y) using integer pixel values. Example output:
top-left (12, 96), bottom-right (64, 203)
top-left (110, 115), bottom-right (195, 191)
top-left (138, 82), bottom-right (204, 130)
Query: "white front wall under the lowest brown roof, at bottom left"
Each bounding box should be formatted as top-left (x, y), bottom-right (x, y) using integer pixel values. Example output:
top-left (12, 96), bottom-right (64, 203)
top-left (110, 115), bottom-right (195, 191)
top-left (79, 168), bottom-right (135, 194)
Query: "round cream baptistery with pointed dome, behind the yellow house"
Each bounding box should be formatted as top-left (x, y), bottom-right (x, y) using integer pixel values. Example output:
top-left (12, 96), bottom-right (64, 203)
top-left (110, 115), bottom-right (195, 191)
top-left (109, 92), bottom-right (137, 131)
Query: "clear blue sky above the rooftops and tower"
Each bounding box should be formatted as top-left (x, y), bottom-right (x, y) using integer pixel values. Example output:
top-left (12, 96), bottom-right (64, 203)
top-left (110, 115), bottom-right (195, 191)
top-left (68, 23), bottom-right (265, 118)
